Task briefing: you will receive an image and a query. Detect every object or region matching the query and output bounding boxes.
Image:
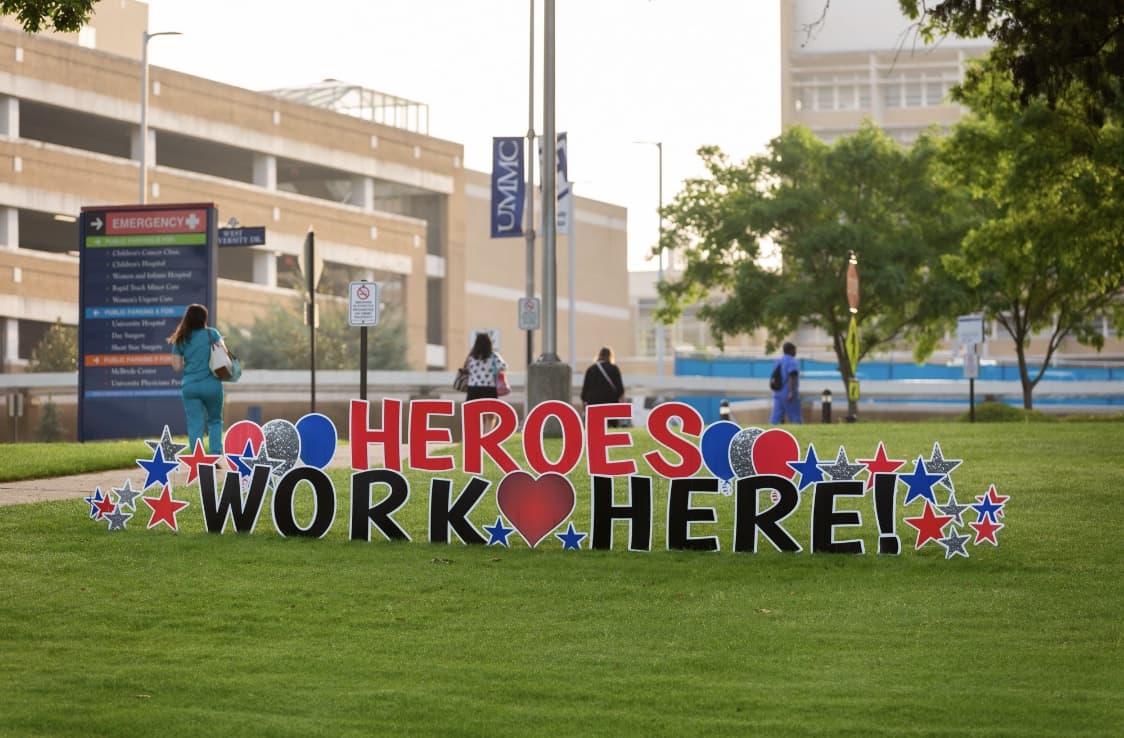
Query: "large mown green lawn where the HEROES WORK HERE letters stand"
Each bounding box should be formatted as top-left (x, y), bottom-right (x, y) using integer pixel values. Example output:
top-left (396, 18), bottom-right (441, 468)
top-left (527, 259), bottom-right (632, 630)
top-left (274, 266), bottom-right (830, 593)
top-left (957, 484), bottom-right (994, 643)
top-left (0, 422), bottom-right (1124, 736)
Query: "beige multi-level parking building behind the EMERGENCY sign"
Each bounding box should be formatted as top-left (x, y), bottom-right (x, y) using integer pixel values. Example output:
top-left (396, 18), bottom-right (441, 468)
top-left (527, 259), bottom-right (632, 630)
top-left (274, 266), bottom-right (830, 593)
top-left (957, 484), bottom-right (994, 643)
top-left (0, 0), bottom-right (633, 373)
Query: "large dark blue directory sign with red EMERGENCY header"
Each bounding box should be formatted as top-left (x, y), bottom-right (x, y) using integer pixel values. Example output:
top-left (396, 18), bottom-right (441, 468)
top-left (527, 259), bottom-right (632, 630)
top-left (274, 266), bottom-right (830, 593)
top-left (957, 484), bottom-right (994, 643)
top-left (78, 203), bottom-right (217, 440)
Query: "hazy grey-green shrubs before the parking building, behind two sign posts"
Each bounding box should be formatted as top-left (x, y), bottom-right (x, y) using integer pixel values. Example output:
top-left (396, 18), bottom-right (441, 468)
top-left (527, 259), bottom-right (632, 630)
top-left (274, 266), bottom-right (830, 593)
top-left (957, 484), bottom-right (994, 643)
top-left (227, 299), bottom-right (408, 371)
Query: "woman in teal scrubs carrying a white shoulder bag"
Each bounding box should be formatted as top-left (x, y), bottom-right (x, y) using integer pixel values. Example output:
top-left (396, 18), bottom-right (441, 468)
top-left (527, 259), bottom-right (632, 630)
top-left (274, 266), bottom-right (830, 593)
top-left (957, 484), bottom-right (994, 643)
top-left (167, 304), bottom-right (226, 454)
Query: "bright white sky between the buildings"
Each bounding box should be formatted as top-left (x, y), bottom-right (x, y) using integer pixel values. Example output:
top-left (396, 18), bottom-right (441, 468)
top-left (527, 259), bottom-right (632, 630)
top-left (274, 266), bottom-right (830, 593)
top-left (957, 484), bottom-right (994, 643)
top-left (142, 0), bottom-right (780, 270)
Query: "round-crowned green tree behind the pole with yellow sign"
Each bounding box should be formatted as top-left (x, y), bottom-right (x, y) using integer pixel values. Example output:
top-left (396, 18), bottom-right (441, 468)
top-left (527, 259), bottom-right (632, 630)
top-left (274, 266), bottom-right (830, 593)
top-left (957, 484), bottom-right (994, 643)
top-left (658, 124), bottom-right (962, 413)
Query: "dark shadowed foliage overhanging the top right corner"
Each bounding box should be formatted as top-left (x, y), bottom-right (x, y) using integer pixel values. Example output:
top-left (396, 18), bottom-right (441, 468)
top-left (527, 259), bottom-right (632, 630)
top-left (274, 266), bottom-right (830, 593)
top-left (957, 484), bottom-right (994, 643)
top-left (898, 0), bottom-right (1124, 122)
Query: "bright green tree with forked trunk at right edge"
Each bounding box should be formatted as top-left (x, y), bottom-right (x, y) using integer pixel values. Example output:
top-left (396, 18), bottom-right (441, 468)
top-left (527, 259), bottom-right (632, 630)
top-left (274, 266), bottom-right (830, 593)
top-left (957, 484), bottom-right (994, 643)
top-left (940, 61), bottom-right (1124, 410)
